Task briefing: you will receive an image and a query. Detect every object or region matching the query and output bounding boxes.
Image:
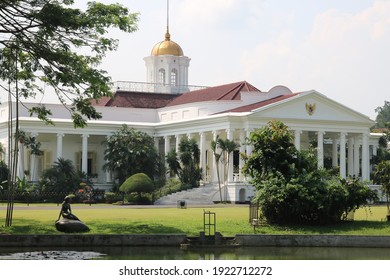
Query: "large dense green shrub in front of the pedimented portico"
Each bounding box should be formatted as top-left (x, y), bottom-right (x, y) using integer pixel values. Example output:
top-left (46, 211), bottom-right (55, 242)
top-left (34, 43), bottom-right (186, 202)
top-left (243, 122), bottom-right (377, 224)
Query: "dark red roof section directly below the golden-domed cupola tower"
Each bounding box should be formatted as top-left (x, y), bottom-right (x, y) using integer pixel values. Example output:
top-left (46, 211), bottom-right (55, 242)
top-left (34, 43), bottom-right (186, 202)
top-left (92, 91), bottom-right (178, 109)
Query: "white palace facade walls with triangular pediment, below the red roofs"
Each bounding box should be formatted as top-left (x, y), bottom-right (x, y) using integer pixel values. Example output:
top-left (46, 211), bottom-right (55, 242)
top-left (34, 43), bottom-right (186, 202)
top-left (0, 88), bottom-right (380, 201)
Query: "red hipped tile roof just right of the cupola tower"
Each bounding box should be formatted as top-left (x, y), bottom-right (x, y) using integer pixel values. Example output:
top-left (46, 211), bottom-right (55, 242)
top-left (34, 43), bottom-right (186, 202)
top-left (168, 81), bottom-right (261, 106)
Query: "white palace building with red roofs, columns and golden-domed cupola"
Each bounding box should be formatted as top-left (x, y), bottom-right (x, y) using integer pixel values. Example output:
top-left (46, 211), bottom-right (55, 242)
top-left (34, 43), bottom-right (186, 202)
top-left (0, 27), bottom-right (380, 203)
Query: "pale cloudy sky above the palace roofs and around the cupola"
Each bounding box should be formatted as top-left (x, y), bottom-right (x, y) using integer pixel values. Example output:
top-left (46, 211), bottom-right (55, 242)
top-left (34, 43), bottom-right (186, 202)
top-left (28, 0), bottom-right (390, 119)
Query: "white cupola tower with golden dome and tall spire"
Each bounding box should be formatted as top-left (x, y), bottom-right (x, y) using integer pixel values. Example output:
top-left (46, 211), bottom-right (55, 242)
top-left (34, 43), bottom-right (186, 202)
top-left (144, 1), bottom-right (191, 94)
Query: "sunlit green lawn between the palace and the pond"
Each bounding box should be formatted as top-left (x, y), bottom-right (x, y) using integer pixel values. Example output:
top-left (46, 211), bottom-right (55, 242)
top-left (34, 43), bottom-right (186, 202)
top-left (0, 204), bottom-right (390, 236)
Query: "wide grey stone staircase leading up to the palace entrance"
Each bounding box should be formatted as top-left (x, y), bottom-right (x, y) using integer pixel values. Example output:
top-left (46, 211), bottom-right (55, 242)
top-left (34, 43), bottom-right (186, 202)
top-left (154, 184), bottom-right (219, 206)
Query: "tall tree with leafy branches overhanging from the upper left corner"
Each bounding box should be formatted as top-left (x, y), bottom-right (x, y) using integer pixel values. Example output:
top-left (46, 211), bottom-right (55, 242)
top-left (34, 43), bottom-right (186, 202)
top-left (0, 0), bottom-right (138, 226)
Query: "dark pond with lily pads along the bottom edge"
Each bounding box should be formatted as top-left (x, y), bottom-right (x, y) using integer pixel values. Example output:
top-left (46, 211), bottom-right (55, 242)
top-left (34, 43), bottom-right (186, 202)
top-left (0, 247), bottom-right (390, 260)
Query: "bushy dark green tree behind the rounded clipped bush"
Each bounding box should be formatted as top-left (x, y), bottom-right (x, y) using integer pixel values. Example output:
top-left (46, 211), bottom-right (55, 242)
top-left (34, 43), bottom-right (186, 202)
top-left (103, 125), bottom-right (160, 186)
